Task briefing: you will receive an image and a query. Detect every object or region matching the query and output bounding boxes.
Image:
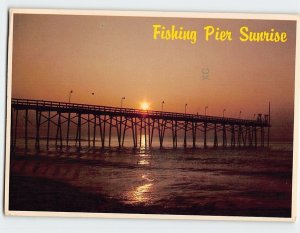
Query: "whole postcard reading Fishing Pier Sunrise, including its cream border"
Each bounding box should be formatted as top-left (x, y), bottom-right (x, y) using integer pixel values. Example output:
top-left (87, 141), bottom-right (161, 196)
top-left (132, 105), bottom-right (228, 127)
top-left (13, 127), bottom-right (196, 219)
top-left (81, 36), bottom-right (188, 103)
top-left (5, 9), bottom-right (300, 221)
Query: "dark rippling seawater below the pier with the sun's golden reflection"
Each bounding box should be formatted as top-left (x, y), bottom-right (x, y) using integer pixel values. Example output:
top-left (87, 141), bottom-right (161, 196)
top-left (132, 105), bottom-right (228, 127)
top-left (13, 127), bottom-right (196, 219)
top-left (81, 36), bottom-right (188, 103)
top-left (10, 138), bottom-right (292, 217)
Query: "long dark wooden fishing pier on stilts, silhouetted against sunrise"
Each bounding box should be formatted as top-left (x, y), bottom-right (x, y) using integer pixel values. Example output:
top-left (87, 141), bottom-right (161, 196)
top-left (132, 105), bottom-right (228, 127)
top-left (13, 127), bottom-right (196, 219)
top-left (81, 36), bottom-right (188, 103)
top-left (11, 99), bottom-right (271, 149)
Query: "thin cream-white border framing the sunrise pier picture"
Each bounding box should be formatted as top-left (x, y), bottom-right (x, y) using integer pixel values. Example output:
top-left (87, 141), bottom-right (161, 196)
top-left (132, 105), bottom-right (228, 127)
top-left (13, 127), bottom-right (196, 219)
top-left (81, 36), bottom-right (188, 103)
top-left (4, 9), bottom-right (300, 222)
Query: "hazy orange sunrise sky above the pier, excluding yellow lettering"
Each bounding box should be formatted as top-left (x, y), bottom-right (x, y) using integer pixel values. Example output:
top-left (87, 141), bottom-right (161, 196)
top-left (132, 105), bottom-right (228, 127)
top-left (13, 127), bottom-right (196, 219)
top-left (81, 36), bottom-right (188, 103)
top-left (12, 15), bottom-right (296, 140)
